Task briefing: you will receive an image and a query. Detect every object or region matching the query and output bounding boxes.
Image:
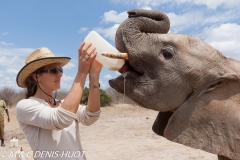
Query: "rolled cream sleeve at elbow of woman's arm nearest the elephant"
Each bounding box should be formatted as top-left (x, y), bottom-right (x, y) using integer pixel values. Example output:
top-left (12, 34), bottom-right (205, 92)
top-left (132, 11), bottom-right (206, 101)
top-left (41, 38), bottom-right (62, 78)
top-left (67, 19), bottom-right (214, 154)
top-left (77, 105), bottom-right (101, 126)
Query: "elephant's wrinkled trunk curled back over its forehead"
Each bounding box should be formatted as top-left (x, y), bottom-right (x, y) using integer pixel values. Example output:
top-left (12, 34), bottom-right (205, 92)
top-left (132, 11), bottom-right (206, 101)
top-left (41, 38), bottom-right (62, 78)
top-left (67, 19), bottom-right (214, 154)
top-left (115, 9), bottom-right (170, 53)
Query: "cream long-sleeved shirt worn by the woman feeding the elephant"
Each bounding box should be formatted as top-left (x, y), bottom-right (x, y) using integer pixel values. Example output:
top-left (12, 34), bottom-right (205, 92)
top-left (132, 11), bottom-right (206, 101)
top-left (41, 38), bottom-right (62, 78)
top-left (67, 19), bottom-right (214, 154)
top-left (16, 97), bottom-right (101, 160)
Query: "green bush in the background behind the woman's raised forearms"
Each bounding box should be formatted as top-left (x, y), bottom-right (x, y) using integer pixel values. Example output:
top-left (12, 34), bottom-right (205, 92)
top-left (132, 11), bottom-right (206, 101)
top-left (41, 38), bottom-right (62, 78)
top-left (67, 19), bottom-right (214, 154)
top-left (80, 87), bottom-right (112, 107)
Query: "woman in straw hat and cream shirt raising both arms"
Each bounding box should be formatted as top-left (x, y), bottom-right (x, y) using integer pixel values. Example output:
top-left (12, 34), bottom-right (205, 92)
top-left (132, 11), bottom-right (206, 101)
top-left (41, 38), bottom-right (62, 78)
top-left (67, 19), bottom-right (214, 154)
top-left (16, 42), bottom-right (102, 160)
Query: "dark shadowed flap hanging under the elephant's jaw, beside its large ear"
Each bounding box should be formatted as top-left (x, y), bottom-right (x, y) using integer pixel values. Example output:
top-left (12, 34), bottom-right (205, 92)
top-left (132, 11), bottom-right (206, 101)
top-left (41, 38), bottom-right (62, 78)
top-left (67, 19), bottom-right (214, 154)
top-left (152, 111), bottom-right (173, 137)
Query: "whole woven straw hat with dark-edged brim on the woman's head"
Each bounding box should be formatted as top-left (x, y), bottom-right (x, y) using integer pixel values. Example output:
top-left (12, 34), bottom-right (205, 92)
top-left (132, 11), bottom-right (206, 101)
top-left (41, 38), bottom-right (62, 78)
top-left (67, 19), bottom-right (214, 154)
top-left (16, 47), bottom-right (71, 88)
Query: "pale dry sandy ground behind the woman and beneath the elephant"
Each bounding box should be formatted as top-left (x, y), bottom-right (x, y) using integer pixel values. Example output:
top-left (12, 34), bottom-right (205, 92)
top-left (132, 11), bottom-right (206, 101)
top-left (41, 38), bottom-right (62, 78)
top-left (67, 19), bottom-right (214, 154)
top-left (0, 104), bottom-right (217, 160)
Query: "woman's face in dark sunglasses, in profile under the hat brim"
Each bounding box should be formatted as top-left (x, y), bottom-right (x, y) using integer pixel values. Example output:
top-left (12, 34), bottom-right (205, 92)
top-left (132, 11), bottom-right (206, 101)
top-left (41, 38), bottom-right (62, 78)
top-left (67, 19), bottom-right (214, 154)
top-left (38, 63), bottom-right (63, 92)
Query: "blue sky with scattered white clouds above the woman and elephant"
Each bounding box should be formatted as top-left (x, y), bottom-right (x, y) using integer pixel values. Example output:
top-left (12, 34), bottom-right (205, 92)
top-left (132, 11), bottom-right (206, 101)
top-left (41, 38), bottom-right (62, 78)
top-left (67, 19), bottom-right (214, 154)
top-left (0, 0), bottom-right (240, 90)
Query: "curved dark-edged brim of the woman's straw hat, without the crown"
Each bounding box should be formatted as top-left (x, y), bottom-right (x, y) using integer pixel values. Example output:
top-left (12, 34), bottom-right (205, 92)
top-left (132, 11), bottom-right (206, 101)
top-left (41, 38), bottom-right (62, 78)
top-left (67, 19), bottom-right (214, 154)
top-left (16, 57), bottom-right (71, 88)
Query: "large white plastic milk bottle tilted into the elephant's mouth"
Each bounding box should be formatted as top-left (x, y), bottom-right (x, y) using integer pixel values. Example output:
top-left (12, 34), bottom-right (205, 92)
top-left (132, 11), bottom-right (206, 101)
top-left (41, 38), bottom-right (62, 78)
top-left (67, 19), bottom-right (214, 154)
top-left (84, 31), bottom-right (125, 71)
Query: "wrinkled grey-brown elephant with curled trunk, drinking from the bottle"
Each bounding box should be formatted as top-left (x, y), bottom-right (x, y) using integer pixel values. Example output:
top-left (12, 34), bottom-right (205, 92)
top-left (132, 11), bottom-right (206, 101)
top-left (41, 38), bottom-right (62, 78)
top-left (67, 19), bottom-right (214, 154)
top-left (109, 9), bottom-right (240, 160)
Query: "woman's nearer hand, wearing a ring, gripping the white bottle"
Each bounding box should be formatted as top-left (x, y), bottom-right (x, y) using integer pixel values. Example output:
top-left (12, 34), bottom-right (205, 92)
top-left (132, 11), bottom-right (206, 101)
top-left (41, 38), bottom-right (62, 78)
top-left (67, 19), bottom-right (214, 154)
top-left (78, 41), bottom-right (97, 75)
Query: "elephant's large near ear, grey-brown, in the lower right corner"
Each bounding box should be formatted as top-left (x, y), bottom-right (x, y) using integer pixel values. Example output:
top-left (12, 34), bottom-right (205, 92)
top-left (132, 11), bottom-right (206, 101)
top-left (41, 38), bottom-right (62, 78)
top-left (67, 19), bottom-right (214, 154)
top-left (164, 77), bottom-right (240, 159)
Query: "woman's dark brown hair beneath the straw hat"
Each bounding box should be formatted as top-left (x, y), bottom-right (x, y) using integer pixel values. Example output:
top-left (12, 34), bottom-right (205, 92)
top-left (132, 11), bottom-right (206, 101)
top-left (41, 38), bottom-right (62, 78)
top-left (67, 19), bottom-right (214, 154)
top-left (25, 66), bottom-right (45, 98)
